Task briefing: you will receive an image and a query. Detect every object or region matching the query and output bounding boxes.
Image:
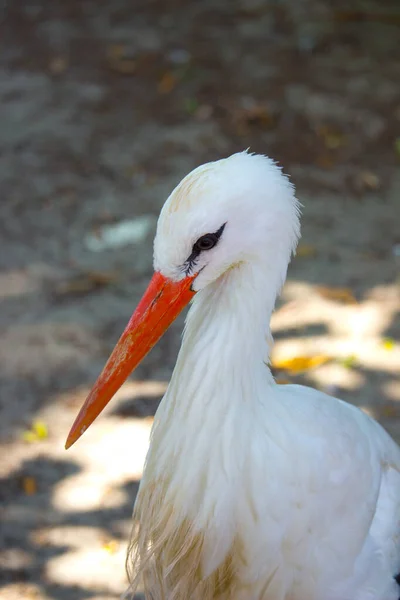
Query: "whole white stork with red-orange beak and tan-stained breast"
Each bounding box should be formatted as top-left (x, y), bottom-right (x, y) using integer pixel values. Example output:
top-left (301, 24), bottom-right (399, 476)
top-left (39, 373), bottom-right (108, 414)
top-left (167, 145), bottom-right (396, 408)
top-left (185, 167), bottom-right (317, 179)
top-left (67, 153), bottom-right (400, 600)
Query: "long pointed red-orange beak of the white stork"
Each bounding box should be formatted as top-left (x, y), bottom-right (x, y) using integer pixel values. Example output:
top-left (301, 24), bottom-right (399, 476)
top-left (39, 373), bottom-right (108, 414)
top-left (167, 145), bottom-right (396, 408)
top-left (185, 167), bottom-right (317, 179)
top-left (65, 272), bottom-right (195, 448)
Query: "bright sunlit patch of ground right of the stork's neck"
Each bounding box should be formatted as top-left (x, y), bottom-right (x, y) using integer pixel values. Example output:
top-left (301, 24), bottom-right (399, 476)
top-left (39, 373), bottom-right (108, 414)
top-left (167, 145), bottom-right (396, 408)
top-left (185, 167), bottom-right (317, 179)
top-left (272, 282), bottom-right (400, 408)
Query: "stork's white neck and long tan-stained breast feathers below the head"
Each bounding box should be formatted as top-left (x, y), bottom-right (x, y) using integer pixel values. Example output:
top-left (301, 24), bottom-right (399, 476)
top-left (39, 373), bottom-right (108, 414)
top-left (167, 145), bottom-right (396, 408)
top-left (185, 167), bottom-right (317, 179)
top-left (127, 258), bottom-right (288, 600)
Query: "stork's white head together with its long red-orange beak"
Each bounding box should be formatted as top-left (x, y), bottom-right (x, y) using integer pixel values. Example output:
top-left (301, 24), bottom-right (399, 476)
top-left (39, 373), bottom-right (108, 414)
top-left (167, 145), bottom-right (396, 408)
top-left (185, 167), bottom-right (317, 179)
top-left (66, 152), bottom-right (300, 448)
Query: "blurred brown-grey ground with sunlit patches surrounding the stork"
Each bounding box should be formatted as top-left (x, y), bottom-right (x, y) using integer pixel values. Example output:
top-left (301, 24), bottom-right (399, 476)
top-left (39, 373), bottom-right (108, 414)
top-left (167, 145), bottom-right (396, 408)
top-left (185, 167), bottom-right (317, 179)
top-left (0, 0), bottom-right (400, 600)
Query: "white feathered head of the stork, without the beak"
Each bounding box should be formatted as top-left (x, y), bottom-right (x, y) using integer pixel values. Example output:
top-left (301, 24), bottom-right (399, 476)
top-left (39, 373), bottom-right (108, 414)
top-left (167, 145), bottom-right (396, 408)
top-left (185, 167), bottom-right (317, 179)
top-left (154, 152), bottom-right (299, 291)
